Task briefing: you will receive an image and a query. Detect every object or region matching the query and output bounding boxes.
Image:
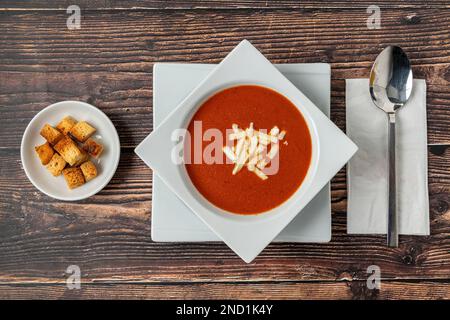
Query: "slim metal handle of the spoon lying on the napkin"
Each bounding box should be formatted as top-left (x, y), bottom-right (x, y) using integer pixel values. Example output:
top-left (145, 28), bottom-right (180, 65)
top-left (387, 113), bottom-right (398, 247)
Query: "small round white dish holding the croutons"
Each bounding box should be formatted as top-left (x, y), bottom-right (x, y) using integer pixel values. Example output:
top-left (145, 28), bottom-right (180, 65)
top-left (20, 101), bottom-right (120, 201)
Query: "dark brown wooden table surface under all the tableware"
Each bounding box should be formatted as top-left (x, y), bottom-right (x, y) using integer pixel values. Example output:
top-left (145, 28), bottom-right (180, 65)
top-left (0, 0), bottom-right (450, 299)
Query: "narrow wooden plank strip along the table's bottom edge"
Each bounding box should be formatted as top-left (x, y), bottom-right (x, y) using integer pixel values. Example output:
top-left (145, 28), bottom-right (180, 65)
top-left (0, 281), bottom-right (450, 300)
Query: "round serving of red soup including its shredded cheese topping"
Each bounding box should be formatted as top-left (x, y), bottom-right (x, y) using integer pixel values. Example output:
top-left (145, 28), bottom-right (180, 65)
top-left (185, 85), bottom-right (312, 214)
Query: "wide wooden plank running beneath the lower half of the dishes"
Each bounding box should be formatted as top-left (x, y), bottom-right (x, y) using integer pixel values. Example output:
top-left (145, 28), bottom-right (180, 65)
top-left (0, 149), bottom-right (450, 283)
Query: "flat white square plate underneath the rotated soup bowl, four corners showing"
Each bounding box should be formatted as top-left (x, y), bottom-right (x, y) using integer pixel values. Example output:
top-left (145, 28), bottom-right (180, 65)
top-left (151, 63), bottom-right (331, 242)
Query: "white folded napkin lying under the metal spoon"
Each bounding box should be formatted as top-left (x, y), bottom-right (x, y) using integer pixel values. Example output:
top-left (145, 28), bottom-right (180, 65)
top-left (346, 79), bottom-right (430, 235)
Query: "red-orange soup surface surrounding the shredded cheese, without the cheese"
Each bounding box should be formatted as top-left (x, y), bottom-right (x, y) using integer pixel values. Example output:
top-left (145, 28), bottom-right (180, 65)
top-left (185, 85), bottom-right (312, 214)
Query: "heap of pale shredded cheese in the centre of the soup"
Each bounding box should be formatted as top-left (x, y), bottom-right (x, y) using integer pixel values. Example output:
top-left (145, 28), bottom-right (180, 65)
top-left (222, 122), bottom-right (287, 180)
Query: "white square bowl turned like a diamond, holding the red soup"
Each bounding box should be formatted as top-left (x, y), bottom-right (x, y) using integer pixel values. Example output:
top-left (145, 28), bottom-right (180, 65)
top-left (136, 40), bottom-right (357, 262)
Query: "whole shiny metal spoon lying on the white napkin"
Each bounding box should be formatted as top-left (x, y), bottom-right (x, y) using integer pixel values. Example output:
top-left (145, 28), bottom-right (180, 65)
top-left (370, 46), bottom-right (413, 247)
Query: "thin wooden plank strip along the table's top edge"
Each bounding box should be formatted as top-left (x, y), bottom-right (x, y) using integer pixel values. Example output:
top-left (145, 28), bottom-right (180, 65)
top-left (0, 0), bottom-right (449, 10)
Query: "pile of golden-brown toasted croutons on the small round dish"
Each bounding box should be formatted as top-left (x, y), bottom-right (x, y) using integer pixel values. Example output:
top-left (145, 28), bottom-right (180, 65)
top-left (35, 116), bottom-right (103, 189)
